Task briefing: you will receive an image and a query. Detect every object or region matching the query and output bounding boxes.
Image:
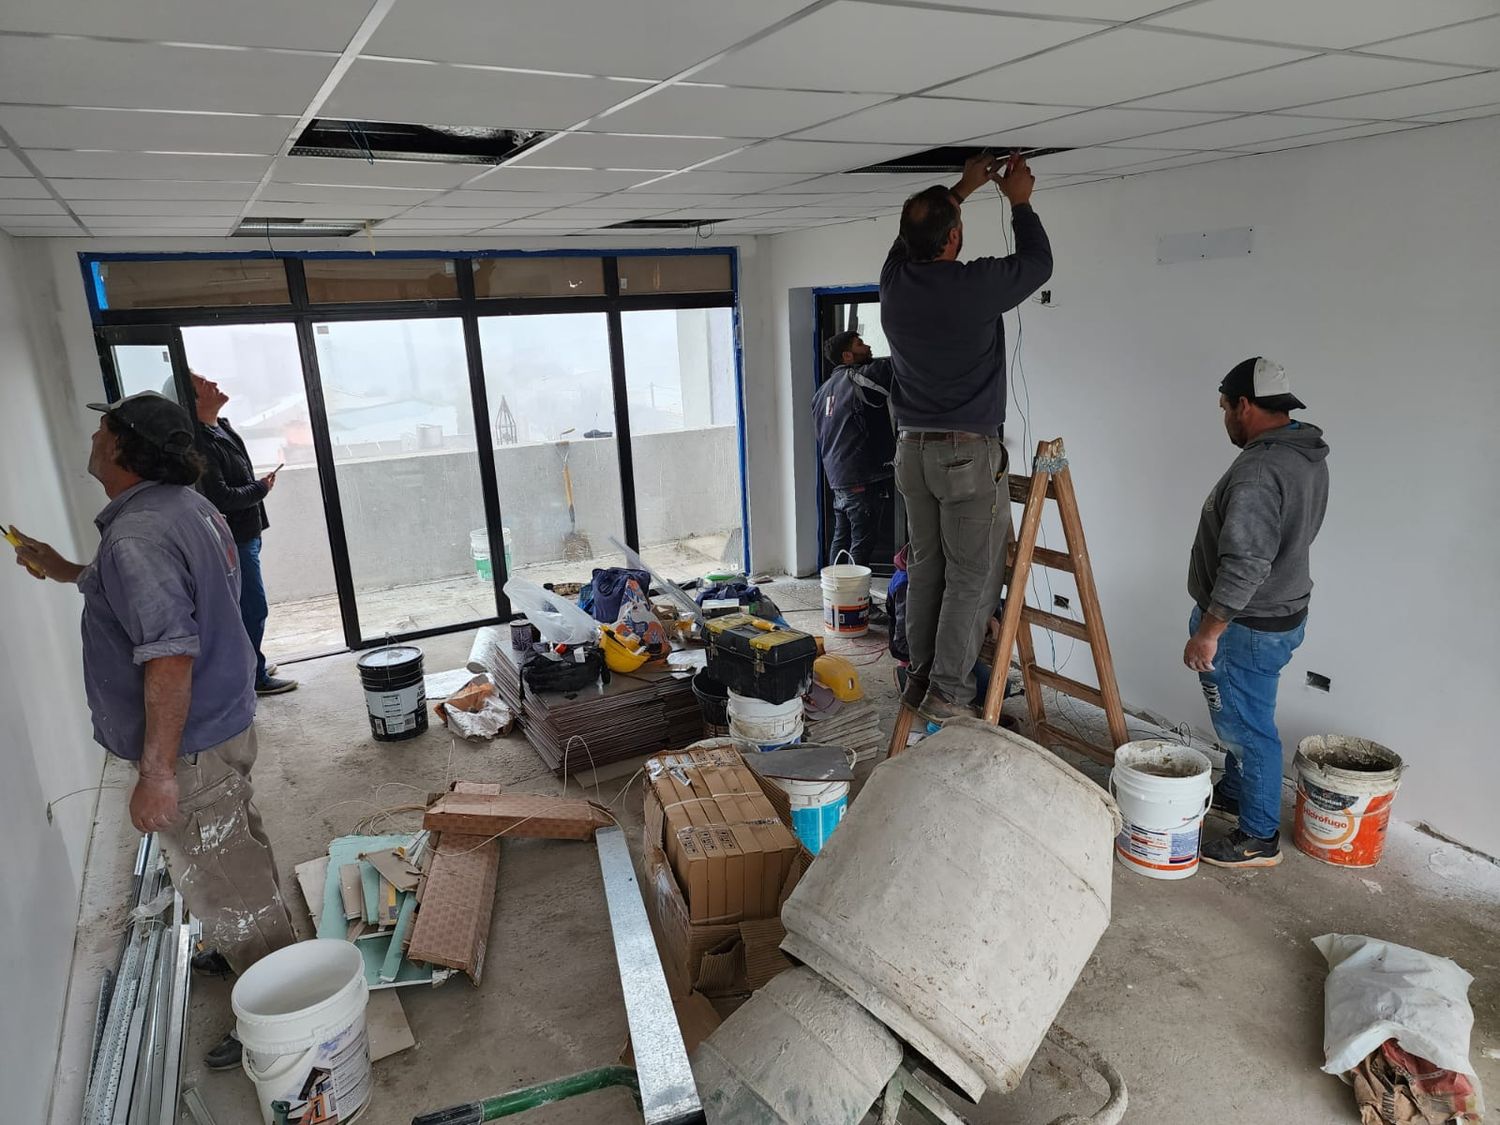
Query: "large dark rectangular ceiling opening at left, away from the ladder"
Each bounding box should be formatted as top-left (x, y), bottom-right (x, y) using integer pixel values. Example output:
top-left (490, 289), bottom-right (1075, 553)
top-left (291, 117), bottom-right (552, 164)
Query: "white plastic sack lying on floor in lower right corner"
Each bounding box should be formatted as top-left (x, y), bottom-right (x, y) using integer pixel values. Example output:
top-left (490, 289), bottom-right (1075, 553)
top-left (1313, 933), bottom-right (1479, 1088)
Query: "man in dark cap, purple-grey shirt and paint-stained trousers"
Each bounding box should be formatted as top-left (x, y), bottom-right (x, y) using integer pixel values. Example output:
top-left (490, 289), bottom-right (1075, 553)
top-left (17, 392), bottom-right (296, 1068)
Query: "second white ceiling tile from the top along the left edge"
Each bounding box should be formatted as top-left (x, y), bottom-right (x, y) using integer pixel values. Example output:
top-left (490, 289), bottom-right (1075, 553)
top-left (0, 36), bottom-right (333, 114)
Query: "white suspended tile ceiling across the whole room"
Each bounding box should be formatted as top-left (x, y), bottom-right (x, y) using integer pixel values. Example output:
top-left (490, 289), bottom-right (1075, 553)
top-left (0, 0), bottom-right (1500, 230)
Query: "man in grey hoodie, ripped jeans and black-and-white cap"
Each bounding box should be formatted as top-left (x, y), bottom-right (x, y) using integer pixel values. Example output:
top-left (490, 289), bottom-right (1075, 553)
top-left (1182, 357), bottom-right (1328, 867)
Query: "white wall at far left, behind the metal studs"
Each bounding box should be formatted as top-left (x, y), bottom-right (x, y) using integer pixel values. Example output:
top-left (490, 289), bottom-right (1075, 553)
top-left (0, 234), bottom-right (104, 1121)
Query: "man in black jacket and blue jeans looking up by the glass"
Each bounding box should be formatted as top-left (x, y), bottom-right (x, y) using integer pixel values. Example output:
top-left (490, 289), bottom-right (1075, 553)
top-left (192, 372), bottom-right (297, 696)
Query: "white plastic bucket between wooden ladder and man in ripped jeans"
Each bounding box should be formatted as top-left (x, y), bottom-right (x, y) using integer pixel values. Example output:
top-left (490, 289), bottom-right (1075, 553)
top-left (1110, 740), bottom-right (1214, 879)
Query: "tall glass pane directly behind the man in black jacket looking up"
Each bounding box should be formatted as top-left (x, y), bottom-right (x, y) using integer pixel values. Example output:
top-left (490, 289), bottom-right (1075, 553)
top-left (182, 324), bottom-right (345, 663)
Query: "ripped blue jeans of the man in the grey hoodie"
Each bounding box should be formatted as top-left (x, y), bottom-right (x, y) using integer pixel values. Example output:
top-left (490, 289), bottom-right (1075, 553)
top-left (1188, 606), bottom-right (1307, 840)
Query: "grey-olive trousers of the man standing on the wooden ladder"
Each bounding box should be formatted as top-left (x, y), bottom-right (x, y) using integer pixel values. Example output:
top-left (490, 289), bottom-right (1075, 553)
top-left (896, 435), bottom-right (1011, 704)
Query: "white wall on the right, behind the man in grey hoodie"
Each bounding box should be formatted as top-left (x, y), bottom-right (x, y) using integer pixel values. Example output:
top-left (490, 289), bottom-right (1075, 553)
top-left (761, 119), bottom-right (1500, 855)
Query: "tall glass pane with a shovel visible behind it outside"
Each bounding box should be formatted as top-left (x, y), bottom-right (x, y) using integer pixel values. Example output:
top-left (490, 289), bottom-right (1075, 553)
top-left (476, 312), bottom-right (624, 582)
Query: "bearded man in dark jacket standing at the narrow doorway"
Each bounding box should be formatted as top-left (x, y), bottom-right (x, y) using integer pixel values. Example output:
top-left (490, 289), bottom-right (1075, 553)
top-left (813, 330), bottom-right (896, 567)
